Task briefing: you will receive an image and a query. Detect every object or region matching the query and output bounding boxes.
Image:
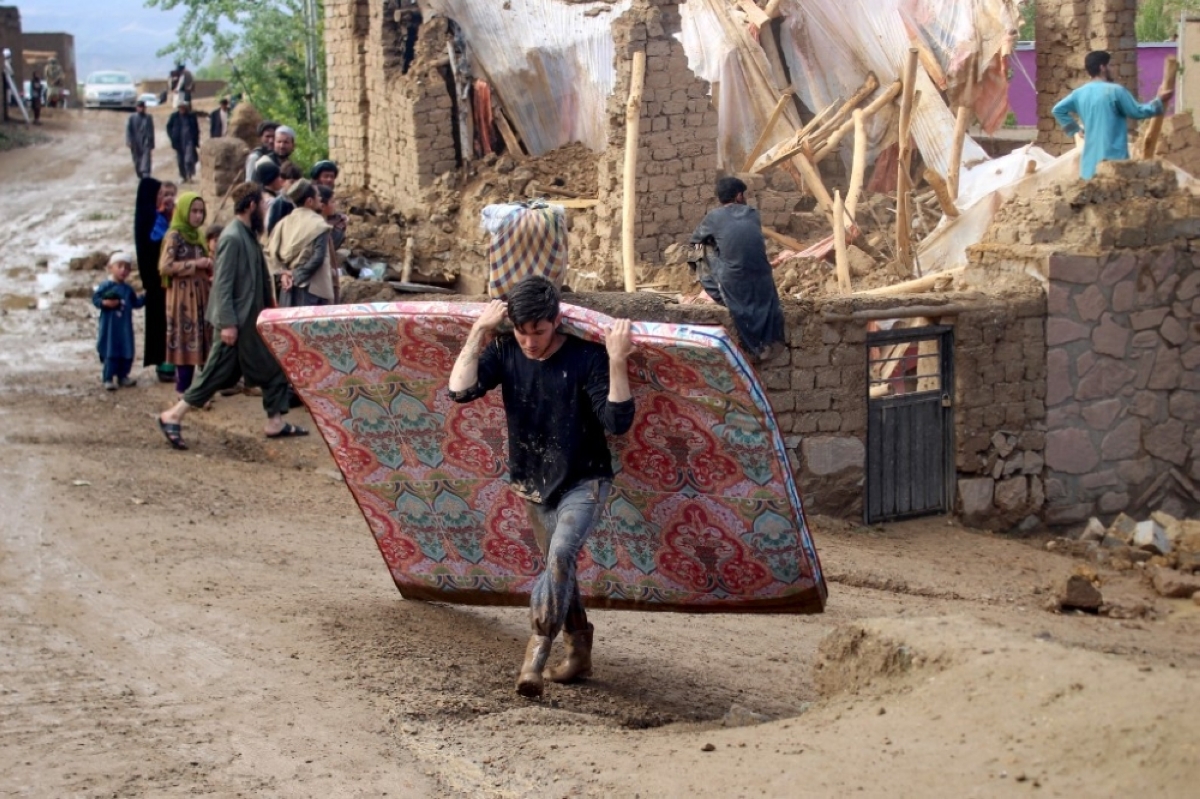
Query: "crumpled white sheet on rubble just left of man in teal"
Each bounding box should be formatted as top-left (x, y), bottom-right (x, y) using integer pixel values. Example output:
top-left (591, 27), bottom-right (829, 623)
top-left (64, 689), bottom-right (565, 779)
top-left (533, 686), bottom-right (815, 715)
top-left (917, 144), bottom-right (1079, 275)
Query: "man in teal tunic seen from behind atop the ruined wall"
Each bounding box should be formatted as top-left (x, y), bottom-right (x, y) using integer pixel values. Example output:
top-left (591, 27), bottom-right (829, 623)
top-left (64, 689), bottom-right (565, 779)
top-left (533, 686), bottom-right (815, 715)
top-left (1054, 50), bottom-right (1175, 180)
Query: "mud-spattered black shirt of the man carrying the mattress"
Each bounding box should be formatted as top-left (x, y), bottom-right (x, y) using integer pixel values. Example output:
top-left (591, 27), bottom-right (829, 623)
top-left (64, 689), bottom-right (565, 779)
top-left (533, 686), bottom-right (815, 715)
top-left (450, 334), bottom-right (634, 506)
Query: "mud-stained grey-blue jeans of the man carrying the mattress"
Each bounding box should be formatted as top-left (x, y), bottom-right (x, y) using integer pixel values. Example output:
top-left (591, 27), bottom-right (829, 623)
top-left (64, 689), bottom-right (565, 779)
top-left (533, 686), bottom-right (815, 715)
top-left (526, 479), bottom-right (612, 638)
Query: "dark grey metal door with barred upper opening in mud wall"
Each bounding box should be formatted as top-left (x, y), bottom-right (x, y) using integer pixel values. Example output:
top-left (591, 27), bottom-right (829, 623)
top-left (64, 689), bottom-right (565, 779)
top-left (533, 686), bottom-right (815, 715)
top-left (864, 325), bottom-right (954, 524)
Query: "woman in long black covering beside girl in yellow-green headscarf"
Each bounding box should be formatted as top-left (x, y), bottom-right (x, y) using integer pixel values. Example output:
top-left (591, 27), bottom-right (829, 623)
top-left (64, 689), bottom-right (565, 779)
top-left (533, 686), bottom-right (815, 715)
top-left (133, 178), bottom-right (176, 383)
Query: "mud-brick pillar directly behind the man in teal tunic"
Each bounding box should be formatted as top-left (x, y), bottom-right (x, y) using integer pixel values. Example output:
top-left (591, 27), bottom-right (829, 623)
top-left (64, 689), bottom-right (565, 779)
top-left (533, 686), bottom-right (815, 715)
top-left (1034, 0), bottom-right (1138, 154)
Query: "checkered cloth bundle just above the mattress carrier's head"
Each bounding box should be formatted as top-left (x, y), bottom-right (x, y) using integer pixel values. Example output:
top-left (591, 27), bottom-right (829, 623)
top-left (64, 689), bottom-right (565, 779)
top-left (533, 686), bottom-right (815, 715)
top-left (482, 200), bottom-right (566, 300)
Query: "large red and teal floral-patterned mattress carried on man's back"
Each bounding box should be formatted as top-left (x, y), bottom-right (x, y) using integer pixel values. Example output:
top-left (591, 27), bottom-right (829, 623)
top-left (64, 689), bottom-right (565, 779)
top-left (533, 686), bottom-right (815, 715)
top-left (258, 302), bottom-right (826, 612)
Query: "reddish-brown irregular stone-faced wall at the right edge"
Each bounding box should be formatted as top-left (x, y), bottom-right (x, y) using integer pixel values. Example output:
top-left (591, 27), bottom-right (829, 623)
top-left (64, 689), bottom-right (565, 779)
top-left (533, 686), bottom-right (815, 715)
top-left (1046, 247), bottom-right (1200, 524)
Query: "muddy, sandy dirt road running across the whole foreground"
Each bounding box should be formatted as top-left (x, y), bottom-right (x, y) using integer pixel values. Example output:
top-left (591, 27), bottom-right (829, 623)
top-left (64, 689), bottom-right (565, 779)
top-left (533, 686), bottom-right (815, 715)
top-left (0, 112), bottom-right (1200, 799)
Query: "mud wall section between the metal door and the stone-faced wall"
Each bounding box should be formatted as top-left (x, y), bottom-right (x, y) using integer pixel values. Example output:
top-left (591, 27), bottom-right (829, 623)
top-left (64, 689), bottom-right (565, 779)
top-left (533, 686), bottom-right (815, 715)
top-left (954, 295), bottom-right (1046, 530)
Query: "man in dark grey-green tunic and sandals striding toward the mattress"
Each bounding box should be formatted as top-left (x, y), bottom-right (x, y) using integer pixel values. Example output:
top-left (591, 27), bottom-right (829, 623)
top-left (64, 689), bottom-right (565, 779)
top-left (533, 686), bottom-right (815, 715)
top-left (158, 182), bottom-right (308, 450)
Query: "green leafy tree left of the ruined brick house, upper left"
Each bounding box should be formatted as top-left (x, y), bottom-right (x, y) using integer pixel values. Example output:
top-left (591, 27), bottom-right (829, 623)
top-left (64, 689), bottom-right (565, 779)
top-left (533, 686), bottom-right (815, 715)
top-left (145, 0), bottom-right (329, 168)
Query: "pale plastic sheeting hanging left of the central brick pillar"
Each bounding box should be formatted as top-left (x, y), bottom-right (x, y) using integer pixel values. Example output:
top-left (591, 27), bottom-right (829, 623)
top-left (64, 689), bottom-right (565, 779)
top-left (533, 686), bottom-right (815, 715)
top-left (422, 0), bottom-right (630, 156)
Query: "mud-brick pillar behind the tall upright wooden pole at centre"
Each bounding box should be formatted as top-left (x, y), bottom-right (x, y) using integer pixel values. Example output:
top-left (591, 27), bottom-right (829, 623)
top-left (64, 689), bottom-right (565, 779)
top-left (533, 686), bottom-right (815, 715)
top-left (571, 0), bottom-right (718, 287)
